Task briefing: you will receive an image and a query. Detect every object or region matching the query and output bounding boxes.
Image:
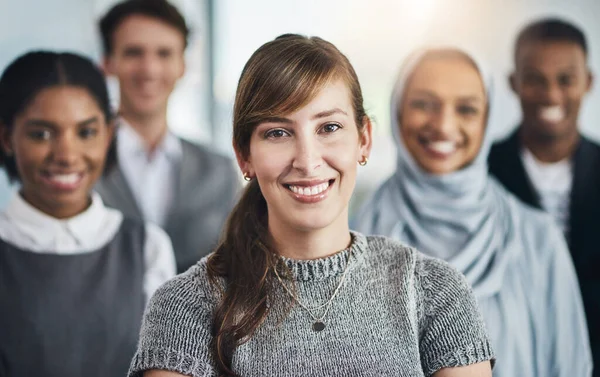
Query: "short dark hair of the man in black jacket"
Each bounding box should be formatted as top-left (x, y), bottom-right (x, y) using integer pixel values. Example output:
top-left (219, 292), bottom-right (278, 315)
top-left (514, 18), bottom-right (588, 59)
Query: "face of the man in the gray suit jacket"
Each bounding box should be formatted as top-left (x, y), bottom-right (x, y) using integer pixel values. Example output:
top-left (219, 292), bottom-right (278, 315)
top-left (105, 15), bottom-right (185, 117)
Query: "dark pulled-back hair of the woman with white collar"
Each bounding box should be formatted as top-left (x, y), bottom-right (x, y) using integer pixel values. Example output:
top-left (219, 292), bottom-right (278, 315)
top-left (0, 51), bottom-right (117, 181)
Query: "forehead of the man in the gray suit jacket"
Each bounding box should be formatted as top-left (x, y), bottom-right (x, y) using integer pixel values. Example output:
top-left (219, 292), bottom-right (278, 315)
top-left (113, 14), bottom-right (185, 50)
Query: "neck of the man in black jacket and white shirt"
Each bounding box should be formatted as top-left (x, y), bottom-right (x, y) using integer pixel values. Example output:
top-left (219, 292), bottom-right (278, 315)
top-left (519, 127), bottom-right (581, 163)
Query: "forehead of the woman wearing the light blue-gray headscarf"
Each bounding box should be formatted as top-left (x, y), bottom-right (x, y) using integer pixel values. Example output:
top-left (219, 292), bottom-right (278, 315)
top-left (406, 56), bottom-right (485, 98)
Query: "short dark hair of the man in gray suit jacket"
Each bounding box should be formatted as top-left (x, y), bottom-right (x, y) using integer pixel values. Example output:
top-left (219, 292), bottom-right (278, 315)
top-left (99, 0), bottom-right (190, 55)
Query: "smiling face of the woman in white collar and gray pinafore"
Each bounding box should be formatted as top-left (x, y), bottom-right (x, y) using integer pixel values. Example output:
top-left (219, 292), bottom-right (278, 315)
top-left (2, 86), bottom-right (113, 218)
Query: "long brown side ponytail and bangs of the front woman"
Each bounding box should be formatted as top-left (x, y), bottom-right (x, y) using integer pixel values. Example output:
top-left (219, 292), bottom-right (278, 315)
top-left (208, 34), bottom-right (366, 376)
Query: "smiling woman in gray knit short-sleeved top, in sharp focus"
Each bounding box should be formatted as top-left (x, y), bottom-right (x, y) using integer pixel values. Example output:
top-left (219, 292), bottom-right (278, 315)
top-left (129, 35), bottom-right (493, 377)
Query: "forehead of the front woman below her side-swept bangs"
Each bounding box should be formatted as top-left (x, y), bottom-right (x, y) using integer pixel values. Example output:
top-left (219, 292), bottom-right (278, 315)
top-left (285, 79), bottom-right (354, 119)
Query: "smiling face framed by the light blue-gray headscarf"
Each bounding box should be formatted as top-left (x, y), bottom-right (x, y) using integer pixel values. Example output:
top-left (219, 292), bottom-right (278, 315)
top-left (399, 55), bottom-right (487, 174)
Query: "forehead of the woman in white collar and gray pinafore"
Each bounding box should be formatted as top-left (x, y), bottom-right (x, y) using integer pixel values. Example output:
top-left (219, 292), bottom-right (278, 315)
top-left (21, 86), bottom-right (102, 124)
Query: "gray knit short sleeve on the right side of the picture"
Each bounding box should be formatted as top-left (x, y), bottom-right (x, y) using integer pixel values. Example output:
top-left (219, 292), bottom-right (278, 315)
top-left (415, 256), bottom-right (494, 376)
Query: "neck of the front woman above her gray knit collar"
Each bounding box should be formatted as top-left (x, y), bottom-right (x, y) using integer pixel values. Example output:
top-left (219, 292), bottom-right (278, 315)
top-left (269, 216), bottom-right (352, 260)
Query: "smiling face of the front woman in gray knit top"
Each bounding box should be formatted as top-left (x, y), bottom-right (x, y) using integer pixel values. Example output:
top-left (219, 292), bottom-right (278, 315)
top-left (238, 80), bottom-right (371, 232)
